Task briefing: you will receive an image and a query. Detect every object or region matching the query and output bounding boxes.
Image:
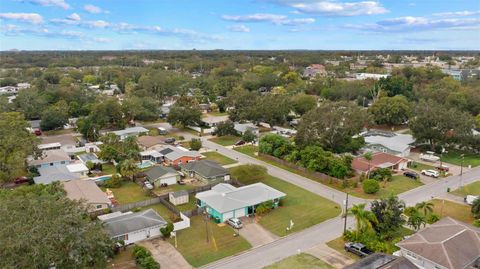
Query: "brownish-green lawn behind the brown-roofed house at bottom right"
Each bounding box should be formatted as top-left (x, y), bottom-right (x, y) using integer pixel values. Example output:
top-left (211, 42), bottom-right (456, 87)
top-left (431, 199), bottom-right (474, 224)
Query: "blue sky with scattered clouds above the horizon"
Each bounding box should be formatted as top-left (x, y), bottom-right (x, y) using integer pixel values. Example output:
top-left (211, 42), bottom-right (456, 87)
top-left (0, 0), bottom-right (480, 50)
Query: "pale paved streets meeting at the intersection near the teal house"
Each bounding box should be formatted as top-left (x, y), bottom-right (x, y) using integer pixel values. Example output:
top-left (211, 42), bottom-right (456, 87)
top-left (195, 138), bottom-right (480, 269)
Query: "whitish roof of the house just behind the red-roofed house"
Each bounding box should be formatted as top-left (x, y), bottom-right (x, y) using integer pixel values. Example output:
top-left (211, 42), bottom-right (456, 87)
top-left (362, 133), bottom-right (415, 152)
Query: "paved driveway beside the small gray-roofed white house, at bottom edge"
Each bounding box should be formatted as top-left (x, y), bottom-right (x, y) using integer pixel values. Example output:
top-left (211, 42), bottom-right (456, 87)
top-left (139, 238), bottom-right (193, 269)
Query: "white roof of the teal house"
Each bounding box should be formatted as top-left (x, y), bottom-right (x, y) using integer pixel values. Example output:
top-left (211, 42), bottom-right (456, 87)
top-left (195, 183), bottom-right (286, 213)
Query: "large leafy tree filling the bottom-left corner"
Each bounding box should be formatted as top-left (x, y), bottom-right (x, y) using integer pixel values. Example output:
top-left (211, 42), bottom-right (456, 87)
top-left (0, 185), bottom-right (113, 269)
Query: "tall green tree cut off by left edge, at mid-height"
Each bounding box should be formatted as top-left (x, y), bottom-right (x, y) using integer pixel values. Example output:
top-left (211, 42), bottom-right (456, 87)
top-left (0, 112), bottom-right (38, 182)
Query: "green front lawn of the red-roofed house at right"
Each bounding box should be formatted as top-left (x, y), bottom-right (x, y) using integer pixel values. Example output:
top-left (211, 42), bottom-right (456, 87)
top-left (344, 175), bottom-right (423, 199)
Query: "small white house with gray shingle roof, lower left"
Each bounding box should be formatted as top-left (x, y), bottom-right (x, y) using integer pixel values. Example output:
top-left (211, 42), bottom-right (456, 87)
top-left (98, 209), bottom-right (167, 245)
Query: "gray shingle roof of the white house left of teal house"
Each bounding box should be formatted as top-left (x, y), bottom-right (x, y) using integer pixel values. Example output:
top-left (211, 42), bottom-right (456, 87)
top-left (103, 209), bottom-right (167, 237)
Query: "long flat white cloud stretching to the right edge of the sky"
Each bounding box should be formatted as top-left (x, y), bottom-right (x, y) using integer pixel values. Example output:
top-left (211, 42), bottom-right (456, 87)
top-left (345, 16), bottom-right (480, 32)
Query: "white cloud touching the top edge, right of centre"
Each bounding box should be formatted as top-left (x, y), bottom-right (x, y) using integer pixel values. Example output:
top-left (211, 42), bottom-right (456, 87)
top-left (271, 0), bottom-right (388, 16)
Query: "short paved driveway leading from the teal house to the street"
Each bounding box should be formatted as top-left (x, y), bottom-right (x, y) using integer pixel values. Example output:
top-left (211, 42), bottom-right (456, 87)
top-left (239, 217), bottom-right (279, 247)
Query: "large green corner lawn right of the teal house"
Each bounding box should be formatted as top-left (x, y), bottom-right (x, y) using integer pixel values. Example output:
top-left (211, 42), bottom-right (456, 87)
top-left (233, 171), bottom-right (341, 236)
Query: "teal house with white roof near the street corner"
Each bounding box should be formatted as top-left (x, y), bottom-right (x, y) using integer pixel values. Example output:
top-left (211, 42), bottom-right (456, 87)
top-left (195, 183), bottom-right (286, 222)
